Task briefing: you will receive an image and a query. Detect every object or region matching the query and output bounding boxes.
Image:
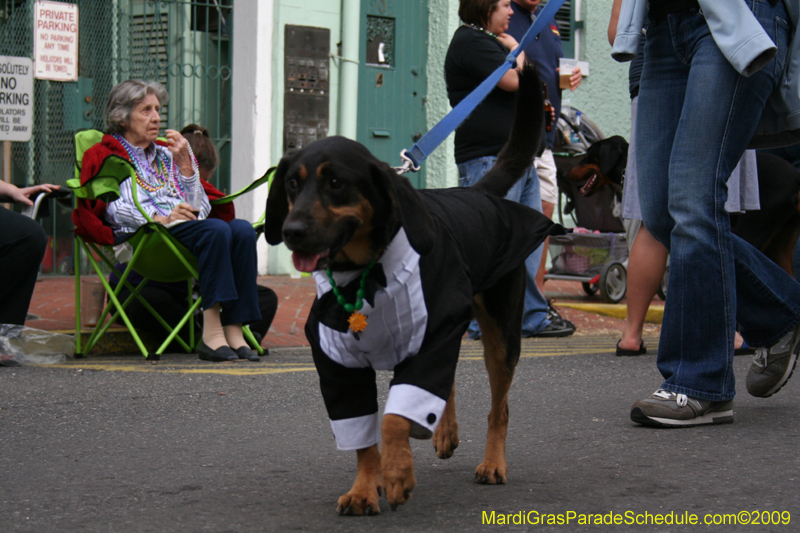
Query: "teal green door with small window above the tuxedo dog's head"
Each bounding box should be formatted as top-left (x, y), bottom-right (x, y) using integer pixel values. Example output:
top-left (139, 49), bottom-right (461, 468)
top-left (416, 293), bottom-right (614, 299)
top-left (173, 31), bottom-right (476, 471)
top-left (357, 0), bottom-right (428, 188)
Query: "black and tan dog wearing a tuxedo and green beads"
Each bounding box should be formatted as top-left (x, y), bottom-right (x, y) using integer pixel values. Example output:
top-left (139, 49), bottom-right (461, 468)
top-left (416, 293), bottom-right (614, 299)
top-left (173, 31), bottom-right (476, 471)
top-left (265, 64), bottom-right (563, 514)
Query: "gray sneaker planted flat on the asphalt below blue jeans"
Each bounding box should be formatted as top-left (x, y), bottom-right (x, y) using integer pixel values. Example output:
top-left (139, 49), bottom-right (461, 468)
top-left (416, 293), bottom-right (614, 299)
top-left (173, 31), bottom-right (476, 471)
top-left (631, 389), bottom-right (733, 427)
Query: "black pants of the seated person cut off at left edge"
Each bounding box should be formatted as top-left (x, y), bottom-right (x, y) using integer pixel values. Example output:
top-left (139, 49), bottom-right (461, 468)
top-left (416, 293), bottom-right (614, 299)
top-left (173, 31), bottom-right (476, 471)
top-left (0, 207), bottom-right (47, 326)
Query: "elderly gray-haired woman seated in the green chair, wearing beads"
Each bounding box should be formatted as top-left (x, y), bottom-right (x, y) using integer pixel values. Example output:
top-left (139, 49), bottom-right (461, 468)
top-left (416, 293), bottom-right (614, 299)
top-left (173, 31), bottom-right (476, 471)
top-left (81, 80), bottom-right (261, 362)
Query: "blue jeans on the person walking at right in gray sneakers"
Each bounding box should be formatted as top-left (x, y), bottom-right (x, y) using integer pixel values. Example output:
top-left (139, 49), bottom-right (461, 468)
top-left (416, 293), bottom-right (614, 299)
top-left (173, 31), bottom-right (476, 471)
top-left (636, 0), bottom-right (800, 401)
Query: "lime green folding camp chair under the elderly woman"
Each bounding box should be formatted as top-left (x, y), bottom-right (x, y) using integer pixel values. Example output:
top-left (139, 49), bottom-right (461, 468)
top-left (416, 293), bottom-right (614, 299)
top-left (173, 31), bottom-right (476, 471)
top-left (67, 130), bottom-right (275, 360)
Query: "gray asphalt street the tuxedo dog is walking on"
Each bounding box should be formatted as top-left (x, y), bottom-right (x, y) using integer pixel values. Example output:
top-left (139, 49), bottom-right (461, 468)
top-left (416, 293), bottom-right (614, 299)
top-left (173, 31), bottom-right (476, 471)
top-left (0, 338), bottom-right (800, 532)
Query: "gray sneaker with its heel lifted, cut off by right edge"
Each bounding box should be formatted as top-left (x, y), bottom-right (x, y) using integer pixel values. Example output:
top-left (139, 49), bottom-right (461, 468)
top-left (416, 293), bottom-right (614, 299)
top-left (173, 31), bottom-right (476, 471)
top-left (746, 325), bottom-right (800, 398)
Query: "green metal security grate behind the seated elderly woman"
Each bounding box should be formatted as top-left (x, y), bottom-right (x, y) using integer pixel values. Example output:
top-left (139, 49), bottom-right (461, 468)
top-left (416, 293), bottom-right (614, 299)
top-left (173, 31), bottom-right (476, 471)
top-left (0, 0), bottom-right (233, 272)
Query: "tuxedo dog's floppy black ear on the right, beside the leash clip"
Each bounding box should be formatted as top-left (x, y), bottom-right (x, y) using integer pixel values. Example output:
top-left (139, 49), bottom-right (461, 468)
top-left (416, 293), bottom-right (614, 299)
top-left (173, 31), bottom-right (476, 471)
top-left (372, 163), bottom-right (436, 255)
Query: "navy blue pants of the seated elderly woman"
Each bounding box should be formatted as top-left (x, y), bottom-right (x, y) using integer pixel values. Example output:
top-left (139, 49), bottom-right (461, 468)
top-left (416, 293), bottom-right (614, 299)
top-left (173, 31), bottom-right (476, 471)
top-left (169, 218), bottom-right (261, 326)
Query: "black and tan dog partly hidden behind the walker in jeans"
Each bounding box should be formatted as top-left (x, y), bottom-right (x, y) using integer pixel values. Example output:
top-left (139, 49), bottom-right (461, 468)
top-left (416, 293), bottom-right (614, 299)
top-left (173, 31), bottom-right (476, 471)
top-left (567, 135), bottom-right (800, 277)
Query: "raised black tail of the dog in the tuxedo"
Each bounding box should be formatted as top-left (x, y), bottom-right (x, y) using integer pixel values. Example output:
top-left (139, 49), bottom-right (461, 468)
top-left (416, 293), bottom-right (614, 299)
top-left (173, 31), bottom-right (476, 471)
top-left (473, 65), bottom-right (545, 196)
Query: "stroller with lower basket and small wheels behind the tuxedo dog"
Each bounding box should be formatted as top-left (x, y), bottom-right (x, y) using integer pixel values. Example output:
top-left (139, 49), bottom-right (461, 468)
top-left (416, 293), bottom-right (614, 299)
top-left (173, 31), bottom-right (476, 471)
top-left (544, 108), bottom-right (628, 303)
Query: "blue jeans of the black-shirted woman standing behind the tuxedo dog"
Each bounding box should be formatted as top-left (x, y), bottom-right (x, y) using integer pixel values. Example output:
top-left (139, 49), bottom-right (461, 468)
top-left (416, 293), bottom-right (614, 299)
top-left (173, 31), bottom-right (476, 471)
top-left (458, 156), bottom-right (550, 339)
